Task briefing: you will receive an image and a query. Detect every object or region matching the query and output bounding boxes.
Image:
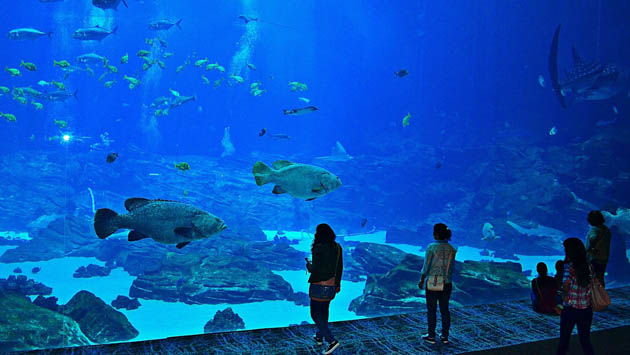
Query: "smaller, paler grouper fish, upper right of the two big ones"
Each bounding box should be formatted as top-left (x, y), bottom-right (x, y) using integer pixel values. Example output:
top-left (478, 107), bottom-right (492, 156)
top-left (253, 160), bottom-right (341, 201)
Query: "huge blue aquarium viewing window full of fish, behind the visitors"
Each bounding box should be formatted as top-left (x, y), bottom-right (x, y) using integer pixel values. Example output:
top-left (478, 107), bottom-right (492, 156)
top-left (0, 0), bottom-right (630, 351)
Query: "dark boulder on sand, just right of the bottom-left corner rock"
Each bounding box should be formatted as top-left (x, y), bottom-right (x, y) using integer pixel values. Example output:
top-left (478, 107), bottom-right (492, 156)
top-left (60, 291), bottom-right (139, 343)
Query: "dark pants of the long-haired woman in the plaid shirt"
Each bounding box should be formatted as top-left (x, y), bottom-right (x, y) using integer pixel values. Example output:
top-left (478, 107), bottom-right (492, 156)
top-left (556, 306), bottom-right (593, 355)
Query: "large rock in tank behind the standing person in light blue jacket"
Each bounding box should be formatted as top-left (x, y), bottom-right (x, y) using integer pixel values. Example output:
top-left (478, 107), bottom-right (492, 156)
top-left (349, 254), bottom-right (530, 316)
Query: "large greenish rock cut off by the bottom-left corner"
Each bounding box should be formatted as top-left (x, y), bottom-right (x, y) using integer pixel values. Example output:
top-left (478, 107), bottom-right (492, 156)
top-left (0, 292), bottom-right (90, 353)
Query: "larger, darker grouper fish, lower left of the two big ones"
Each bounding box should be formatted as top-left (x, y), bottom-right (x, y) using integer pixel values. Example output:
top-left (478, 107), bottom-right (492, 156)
top-left (94, 197), bottom-right (227, 249)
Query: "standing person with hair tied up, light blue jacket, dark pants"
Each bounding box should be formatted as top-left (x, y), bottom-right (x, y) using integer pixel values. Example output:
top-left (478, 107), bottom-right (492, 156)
top-left (418, 223), bottom-right (457, 344)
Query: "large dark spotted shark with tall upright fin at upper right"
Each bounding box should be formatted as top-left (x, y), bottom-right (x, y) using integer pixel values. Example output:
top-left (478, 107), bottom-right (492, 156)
top-left (549, 25), bottom-right (630, 108)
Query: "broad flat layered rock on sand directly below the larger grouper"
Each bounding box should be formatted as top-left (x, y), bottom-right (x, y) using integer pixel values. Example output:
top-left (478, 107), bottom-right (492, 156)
top-left (129, 253), bottom-right (304, 304)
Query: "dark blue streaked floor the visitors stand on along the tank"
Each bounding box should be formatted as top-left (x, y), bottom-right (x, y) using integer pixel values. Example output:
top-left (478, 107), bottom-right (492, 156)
top-left (27, 286), bottom-right (630, 354)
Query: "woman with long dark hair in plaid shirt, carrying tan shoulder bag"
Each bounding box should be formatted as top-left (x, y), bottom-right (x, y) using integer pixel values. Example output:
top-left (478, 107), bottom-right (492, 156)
top-left (557, 238), bottom-right (594, 355)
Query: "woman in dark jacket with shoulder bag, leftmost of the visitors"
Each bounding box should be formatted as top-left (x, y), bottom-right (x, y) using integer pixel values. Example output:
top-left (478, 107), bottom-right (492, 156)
top-left (306, 223), bottom-right (343, 354)
